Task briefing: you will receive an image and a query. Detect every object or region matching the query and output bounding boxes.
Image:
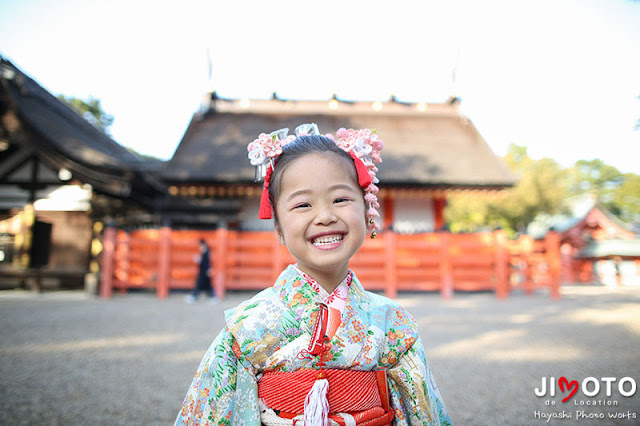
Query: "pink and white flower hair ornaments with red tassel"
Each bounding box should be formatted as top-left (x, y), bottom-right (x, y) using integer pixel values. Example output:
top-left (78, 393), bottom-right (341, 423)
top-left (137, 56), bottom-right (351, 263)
top-left (247, 123), bottom-right (384, 238)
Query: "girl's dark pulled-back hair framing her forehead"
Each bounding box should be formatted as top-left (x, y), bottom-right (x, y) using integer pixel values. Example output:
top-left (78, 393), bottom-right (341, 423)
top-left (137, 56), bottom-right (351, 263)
top-left (269, 135), bottom-right (364, 226)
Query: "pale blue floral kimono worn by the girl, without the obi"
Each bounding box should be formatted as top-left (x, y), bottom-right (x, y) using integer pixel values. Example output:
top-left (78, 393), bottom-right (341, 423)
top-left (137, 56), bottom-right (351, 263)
top-left (176, 265), bottom-right (450, 425)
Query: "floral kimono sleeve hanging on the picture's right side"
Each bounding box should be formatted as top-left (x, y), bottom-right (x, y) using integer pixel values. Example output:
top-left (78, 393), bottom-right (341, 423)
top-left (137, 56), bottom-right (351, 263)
top-left (387, 336), bottom-right (451, 425)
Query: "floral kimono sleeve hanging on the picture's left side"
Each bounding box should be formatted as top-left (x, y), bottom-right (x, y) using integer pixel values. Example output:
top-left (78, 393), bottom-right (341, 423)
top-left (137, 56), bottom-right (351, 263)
top-left (175, 328), bottom-right (260, 425)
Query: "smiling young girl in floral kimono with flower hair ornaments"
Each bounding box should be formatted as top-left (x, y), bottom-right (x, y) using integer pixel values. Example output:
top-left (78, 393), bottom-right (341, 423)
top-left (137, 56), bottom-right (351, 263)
top-left (176, 124), bottom-right (450, 426)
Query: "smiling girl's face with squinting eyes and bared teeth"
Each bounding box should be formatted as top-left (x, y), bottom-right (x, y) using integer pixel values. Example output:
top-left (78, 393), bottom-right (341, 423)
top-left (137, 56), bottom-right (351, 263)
top-left (275, 153), bottom-right (366, 292)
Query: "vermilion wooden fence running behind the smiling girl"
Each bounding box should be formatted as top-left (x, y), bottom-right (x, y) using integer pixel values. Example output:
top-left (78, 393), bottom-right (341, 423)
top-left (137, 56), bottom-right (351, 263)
top-left (101, 228), bottom-right (562, 298)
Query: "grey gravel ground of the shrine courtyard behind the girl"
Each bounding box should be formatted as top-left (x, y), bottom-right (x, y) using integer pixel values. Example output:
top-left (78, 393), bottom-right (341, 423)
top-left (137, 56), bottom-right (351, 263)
top-left (0, 287), bottom-right (640, 425)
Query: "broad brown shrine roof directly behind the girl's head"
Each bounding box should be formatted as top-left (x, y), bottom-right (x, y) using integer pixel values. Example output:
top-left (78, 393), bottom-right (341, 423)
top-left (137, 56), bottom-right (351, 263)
top-left (162, 96), bottom-right (516, 189)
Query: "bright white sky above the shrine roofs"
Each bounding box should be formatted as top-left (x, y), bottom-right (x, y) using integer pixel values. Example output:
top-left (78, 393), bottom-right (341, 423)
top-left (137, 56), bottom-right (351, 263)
top-left (0, 0), bottom-right (640, 174)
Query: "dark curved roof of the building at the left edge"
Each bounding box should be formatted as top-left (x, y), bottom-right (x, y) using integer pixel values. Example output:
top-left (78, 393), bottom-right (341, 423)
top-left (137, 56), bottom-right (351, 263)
top-left (0, 57), bottom-right (166, 205)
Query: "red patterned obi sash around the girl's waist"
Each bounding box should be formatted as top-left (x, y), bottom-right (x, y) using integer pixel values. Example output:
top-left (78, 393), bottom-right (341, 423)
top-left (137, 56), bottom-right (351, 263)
top-left (258, 369), bottom-right (394, 426)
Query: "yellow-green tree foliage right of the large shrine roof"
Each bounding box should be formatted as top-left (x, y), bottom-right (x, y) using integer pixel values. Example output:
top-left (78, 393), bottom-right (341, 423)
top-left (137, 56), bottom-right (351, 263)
top-left (446, 144), bottom-right (640, 236)
